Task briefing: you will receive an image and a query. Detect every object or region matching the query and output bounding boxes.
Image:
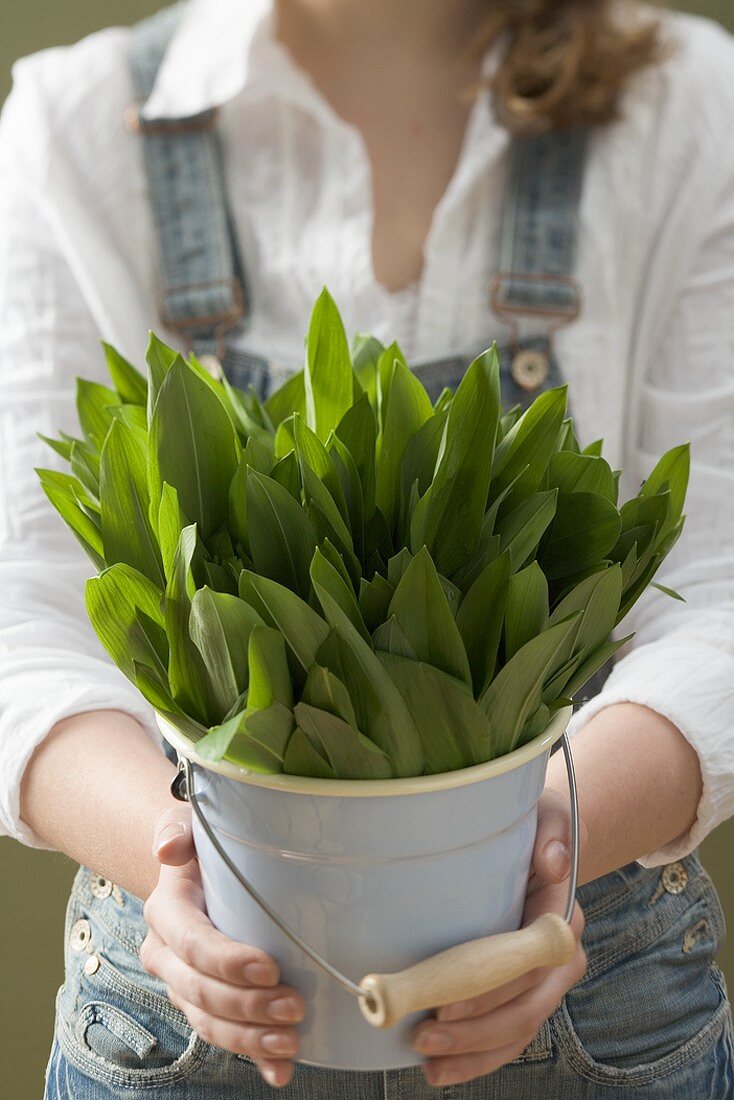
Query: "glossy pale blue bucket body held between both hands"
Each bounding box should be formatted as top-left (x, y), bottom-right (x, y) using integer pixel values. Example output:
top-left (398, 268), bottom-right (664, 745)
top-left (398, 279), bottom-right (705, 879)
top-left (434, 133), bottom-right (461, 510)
top-left (161, 712), bottom-right (569, 1070)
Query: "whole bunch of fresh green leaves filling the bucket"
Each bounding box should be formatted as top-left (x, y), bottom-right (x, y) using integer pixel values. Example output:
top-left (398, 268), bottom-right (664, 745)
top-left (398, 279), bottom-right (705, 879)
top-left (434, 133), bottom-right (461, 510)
top-left (39, 290), bottom-right (689, 779)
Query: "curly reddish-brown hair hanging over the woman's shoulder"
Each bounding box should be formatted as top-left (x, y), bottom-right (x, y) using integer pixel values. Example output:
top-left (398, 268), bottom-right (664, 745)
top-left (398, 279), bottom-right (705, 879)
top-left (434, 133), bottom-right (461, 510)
top-left (474, 0), bottom-right (670, 134)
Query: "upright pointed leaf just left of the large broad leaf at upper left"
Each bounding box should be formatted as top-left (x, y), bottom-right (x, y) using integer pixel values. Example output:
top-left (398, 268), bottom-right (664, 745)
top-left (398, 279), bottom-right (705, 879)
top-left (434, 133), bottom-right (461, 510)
top-left (100, 420), bottom-right (165, 587)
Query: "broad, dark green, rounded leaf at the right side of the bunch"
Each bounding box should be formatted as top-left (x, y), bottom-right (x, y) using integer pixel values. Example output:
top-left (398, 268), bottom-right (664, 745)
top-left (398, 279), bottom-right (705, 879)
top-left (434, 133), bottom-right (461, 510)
top-left (538, 493), bottom-right (622, 581)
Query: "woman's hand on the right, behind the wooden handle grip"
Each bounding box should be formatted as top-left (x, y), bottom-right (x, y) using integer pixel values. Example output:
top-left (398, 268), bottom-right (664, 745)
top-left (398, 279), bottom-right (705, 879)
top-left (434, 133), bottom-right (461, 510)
top-left (413, 790), bottom-right (587, 1086)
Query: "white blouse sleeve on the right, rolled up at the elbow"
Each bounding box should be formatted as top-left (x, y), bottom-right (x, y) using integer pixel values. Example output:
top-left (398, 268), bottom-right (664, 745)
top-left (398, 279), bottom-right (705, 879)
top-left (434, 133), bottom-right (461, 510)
top-left (571, 51), bottom-right (734, 867)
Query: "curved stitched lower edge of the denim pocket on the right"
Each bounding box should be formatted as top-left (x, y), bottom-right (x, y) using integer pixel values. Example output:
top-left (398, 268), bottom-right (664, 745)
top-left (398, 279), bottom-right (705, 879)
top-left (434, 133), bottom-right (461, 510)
top-left (555, 998), bottom-right (730, 1088)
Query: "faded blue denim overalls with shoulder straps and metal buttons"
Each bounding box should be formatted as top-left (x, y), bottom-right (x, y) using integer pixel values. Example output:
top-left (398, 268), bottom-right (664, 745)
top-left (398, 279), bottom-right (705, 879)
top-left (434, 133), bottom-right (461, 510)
top-left (45, 9), bottom-right (734, 1100)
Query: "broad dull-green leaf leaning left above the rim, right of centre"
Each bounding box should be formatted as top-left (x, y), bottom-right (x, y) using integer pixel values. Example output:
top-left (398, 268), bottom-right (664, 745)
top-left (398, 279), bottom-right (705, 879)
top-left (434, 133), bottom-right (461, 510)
top-left (380, 652), bottom-right (493, 774)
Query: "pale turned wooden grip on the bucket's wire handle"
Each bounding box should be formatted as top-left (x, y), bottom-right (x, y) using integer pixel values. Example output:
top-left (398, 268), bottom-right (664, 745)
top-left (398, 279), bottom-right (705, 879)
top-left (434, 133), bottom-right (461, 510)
top-left (360, 913), bottom-right (577, 1027)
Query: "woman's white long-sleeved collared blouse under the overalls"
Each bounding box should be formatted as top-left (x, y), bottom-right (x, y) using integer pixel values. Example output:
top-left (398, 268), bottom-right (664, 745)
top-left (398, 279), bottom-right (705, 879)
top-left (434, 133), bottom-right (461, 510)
top-left (0, 0), bottom-right (734, 866)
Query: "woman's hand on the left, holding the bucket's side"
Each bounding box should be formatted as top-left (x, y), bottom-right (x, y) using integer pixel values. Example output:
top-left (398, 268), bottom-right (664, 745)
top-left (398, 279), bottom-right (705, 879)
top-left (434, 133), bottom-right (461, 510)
top-left (140, 806), bottom-right (305, 1087)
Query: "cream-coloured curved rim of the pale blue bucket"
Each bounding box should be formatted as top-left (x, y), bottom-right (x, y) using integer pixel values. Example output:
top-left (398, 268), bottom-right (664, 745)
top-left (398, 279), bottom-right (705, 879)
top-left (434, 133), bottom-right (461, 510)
top-left (155, 706), bottom-right (573, 799)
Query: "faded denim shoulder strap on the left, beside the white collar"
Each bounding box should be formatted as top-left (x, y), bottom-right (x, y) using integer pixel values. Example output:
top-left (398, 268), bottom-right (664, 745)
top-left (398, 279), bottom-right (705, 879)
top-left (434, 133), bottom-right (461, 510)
top-left (127, 3), bottom-right (248, 356)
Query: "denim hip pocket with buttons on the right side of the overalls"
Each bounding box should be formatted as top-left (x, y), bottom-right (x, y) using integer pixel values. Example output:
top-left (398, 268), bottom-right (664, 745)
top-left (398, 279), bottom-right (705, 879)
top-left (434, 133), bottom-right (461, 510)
top-left (556, 859), bottom-right (731, 1082)
